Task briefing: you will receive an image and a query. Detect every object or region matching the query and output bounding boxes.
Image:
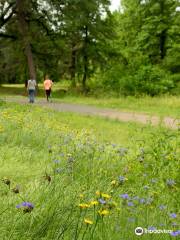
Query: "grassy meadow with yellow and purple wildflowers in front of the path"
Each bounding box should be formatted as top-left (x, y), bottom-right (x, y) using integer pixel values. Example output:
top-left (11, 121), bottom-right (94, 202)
top-left (0, 102), bottom-right (180, 240)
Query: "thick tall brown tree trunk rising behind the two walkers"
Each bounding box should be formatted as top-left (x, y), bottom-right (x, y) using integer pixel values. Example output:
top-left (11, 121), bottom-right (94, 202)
top-left (16, 0), bottom-right (36, 79)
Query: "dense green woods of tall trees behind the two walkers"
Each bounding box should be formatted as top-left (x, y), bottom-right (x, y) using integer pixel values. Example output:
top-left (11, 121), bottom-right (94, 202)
top-left (0, 0), bottom-right (180, 96)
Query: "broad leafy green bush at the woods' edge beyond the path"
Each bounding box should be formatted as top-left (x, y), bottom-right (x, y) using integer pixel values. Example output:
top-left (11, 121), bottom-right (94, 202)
top-left (94, 65), bottom-right (175, 96)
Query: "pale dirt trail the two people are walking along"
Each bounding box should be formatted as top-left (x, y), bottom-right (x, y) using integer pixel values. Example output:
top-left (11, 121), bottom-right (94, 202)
top-left (5, 97), bottom-right (180, 129)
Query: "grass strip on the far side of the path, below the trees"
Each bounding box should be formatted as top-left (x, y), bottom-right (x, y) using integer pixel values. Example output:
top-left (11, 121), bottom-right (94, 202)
top-left (0, 83), bottom-right (180, 118)
